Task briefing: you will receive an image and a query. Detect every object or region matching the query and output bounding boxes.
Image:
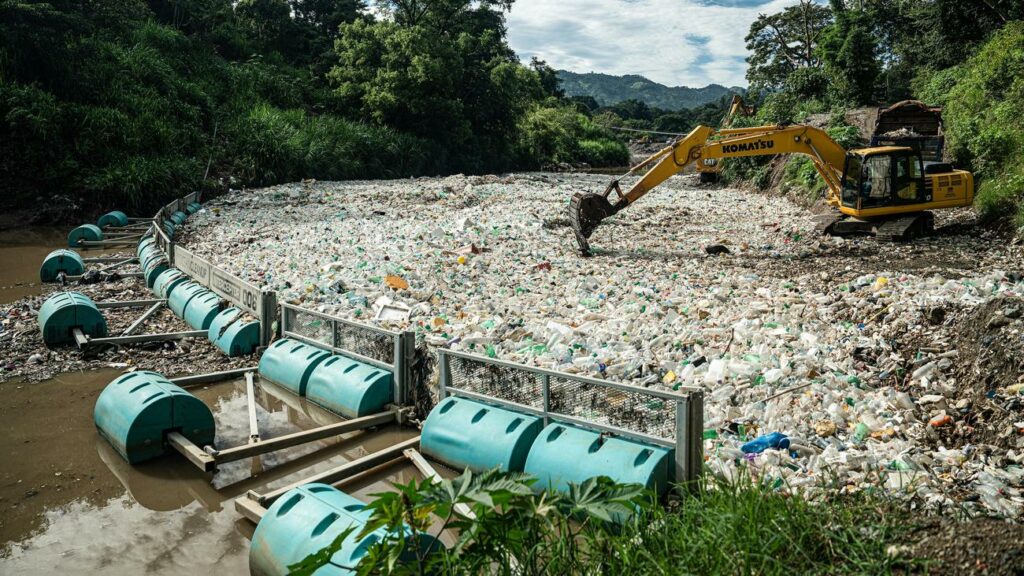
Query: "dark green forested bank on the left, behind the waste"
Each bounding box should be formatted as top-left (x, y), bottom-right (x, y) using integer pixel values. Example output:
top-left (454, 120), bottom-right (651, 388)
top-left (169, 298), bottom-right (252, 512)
top-left (0, 0), bottom-right (628, 219)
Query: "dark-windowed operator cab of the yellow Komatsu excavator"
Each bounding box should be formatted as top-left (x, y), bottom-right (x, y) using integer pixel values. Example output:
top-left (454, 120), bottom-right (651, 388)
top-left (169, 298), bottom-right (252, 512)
top-left (841, 147), bottom-right (932, 211)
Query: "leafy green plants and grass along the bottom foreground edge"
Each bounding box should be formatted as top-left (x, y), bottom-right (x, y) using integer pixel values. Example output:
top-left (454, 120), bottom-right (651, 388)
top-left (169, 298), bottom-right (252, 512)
top-left (292, 470), bottom-right (921, 576)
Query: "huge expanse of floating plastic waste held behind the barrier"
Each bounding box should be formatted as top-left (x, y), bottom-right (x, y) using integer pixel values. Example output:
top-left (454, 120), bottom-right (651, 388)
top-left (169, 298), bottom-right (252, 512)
top-left (182, 174), bottom-right (1024, 518)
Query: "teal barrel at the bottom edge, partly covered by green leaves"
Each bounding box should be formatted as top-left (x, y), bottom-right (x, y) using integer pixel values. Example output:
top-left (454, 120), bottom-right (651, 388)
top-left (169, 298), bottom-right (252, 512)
top-left (249, 484), bottom-right (441, 576)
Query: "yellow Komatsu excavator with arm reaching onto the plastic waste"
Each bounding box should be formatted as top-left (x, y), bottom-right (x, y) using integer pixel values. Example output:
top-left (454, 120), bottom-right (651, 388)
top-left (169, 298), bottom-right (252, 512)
top-left (569, 125), bottom-right (974, 256)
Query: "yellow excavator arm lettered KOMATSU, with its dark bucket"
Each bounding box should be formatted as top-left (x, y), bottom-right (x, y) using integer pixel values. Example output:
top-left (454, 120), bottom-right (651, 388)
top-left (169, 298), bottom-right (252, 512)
top-left (569, 125), bottom-right (846, 256)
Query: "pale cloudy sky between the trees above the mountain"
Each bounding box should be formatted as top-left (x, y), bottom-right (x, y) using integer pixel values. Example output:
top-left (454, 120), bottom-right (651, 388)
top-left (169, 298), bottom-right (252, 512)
top-left (508, 0), bottom-right (797, 87)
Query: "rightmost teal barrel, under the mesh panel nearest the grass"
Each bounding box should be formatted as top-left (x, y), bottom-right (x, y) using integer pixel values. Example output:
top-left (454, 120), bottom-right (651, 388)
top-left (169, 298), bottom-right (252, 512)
top-left (525, 422), bottom-right (674, 495)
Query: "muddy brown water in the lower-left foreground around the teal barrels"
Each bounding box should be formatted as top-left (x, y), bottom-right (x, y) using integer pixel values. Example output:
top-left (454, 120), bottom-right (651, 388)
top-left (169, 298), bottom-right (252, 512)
top-left (0, 370), bottom-right (420, 576)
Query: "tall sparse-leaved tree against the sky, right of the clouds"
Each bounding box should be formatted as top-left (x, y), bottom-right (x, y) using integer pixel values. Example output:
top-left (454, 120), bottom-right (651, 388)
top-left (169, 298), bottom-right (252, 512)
top-left (745, 0), bottom-right (831, 88)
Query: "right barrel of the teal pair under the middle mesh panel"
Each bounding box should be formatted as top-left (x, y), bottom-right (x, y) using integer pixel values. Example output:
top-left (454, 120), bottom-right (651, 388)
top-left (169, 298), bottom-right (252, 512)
top-left (306, 356), bottom-right (394, 418)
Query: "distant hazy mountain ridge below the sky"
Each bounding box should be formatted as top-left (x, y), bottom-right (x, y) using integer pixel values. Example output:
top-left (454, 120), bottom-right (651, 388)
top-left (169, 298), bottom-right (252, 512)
top-left (558, 70), bottom-right (745, 110)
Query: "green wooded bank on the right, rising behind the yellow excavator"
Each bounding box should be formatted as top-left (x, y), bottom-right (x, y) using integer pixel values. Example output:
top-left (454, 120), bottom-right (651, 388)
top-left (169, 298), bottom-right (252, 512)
top-left (725, 0), bottom-right (1024, 225)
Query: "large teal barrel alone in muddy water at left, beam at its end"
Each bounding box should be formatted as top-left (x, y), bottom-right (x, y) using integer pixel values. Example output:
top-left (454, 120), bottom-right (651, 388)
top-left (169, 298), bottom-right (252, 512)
top-left (92, 370), bottom-right (215, 464)
